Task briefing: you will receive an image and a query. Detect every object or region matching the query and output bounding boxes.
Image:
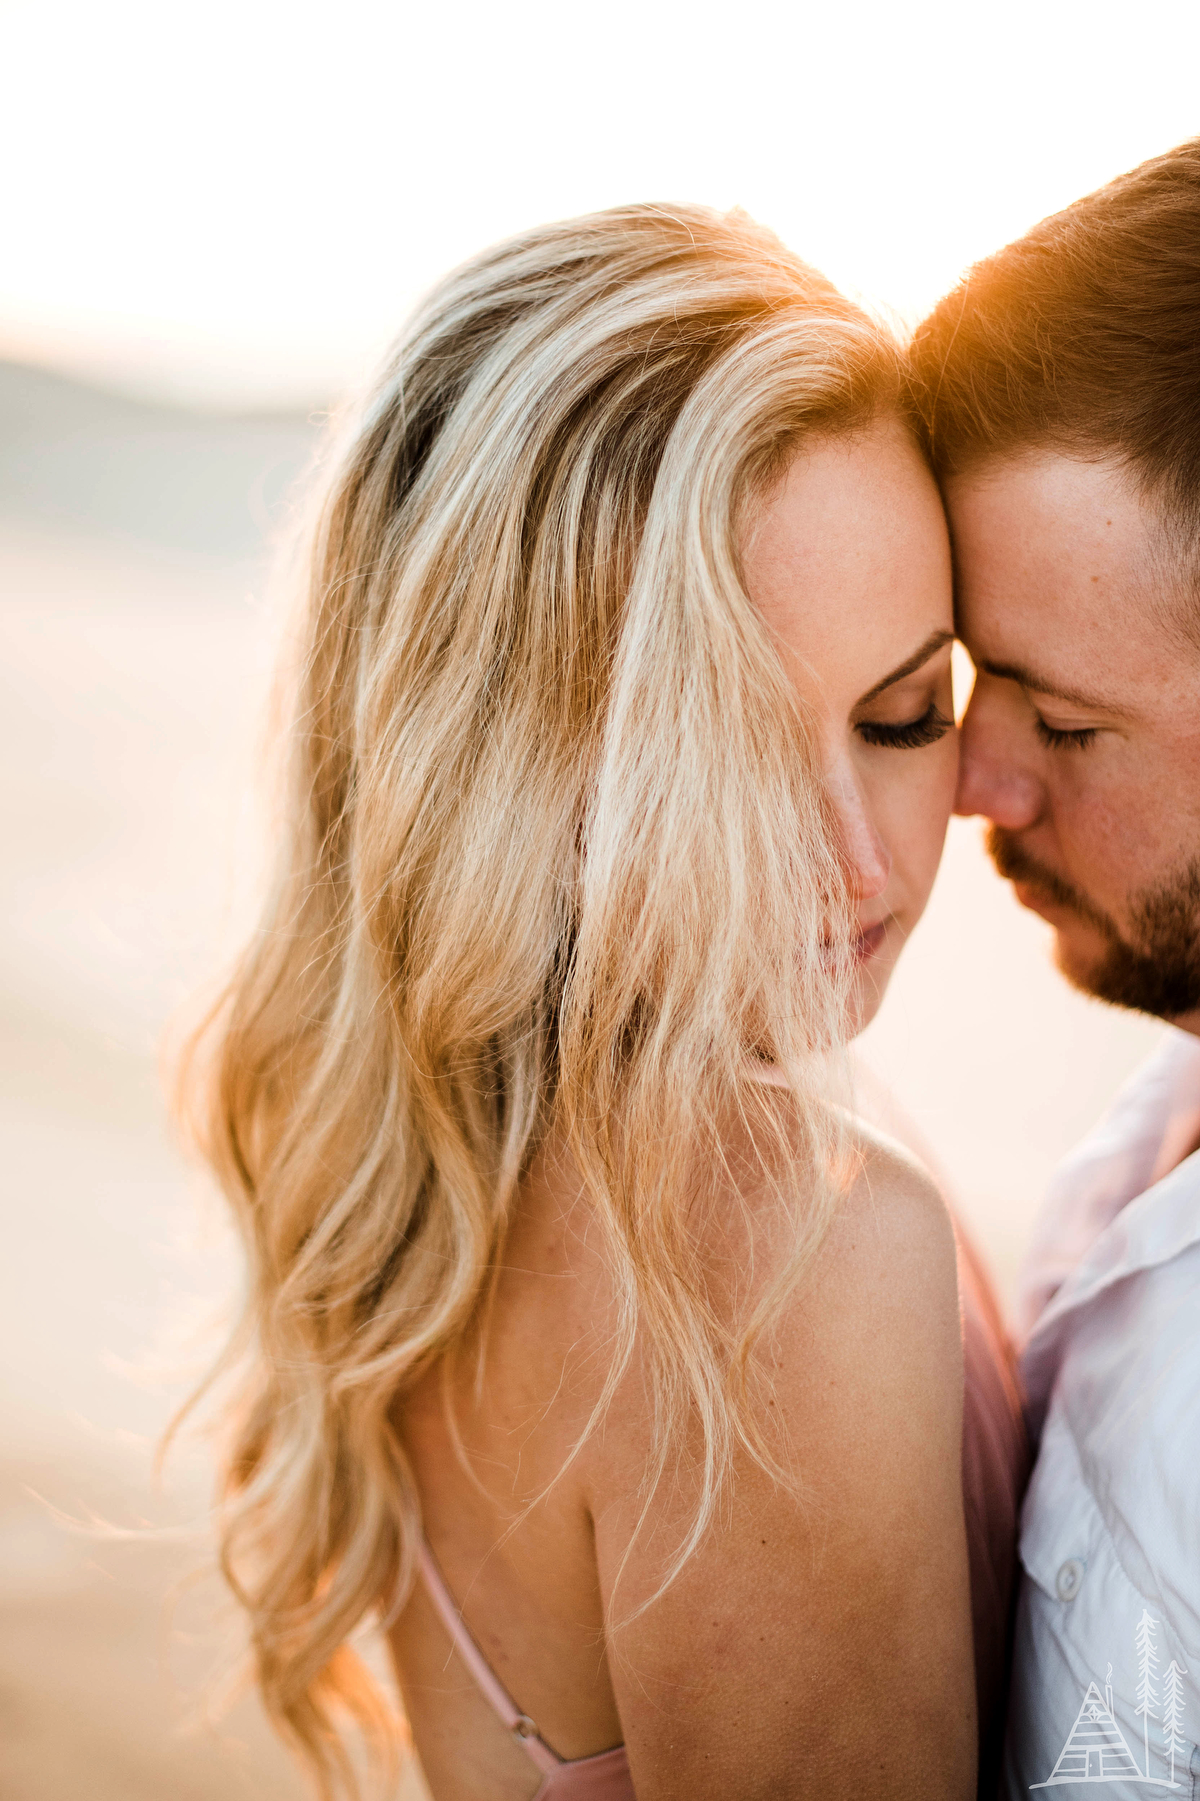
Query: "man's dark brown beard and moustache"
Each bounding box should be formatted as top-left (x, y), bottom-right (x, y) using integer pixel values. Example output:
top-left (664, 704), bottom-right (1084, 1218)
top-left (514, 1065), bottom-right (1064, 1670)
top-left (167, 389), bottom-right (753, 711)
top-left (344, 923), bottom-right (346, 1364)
top-left (987, 825), bottom-right (1200, 1019)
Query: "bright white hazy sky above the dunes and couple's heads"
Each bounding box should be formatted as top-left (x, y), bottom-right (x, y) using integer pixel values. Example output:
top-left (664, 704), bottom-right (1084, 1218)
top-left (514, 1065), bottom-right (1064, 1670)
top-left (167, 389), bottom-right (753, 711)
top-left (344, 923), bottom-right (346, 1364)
top-left (0, 0), bottom-right (1200, 405)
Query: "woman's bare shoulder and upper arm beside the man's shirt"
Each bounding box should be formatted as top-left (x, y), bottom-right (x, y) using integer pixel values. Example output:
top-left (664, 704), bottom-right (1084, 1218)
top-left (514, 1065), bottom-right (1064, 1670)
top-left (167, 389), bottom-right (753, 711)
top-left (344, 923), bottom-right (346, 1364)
top-left (593, 1124), bottom-right (975, 1801)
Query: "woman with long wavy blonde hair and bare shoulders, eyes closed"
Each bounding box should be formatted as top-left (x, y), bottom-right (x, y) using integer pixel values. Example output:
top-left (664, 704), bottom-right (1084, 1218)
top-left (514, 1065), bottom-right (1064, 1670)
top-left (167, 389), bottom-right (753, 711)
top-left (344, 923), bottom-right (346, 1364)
top-left (187, 205), bottom-right (1023, 1801)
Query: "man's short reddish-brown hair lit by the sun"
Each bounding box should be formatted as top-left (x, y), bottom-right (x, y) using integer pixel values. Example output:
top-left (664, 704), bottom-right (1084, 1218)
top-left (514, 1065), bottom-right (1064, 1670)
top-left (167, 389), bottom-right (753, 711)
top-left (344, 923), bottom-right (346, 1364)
top-left (912, 139), bottom-right (1200, 540)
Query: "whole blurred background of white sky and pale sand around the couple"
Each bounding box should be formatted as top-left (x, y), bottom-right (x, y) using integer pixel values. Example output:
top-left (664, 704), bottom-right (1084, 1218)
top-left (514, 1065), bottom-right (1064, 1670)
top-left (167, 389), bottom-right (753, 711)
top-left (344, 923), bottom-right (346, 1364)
top-left (0, 0), bottom-right (1200, 1801)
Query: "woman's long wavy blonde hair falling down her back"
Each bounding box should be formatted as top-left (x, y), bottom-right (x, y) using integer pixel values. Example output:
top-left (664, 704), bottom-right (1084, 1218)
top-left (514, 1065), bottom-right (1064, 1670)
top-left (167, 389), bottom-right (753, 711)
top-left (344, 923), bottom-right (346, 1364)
top-left (180, 205), bottom-right (903, 1794)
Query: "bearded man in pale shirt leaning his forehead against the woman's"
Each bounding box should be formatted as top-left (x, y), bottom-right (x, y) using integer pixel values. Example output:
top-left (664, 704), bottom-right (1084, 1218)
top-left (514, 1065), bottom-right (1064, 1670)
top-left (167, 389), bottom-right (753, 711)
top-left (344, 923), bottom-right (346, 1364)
top-left (914, 140), bottom-right (1200, 1801)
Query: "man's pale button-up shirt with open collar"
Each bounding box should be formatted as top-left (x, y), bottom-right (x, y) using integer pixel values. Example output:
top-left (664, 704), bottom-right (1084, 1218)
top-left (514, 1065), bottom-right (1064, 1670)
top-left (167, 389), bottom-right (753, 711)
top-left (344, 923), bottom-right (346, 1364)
top-left (1002, 1032), bottom-right (1200, 1801)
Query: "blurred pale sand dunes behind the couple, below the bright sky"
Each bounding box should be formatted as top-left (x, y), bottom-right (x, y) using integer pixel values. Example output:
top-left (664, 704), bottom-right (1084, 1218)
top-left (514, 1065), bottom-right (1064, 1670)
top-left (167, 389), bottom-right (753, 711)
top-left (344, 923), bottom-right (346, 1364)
top-left (0, 367), bottom-right (1159, 1801)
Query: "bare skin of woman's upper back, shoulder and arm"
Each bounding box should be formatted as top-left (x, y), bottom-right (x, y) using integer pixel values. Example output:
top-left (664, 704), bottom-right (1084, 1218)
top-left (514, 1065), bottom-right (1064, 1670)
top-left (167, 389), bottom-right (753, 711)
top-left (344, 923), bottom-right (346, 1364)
top-left (393, 1138), bottom-right (973, 1801)
